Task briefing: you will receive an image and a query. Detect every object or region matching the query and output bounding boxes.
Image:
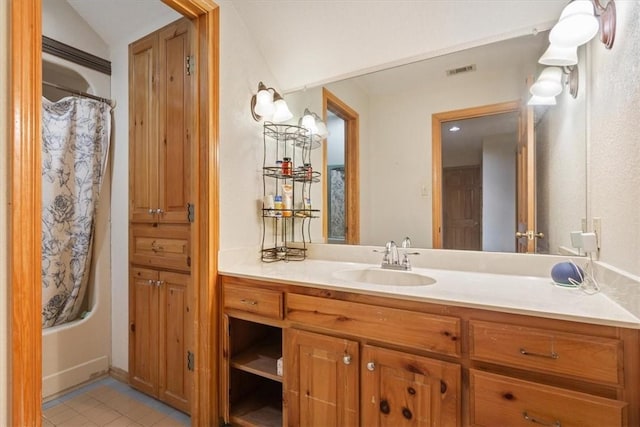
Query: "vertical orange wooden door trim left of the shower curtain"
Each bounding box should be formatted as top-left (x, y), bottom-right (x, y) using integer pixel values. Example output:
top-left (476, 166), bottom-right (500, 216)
top-left (7, 0), bottom-right (42, 426)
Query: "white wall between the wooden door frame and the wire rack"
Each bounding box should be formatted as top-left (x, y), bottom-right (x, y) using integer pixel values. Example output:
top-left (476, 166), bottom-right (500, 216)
top-left (218, 0), bottom-right (282, 251)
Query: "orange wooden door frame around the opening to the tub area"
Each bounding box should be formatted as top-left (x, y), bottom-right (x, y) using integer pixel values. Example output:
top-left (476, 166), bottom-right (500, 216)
top-left (7, 0), bottom-right (220, 426)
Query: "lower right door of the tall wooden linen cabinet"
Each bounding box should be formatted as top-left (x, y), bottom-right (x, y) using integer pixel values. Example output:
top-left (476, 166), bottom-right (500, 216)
top-left (158, 272), bottom-right (194, 413)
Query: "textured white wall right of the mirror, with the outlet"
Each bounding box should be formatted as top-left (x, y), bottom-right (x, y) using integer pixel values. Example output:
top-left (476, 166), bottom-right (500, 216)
top-left (586, 1), bottom-right (640, 275)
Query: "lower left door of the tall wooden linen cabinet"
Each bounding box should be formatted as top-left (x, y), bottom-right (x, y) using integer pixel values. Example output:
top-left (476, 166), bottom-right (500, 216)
top-left (129, 268), bottom-right (159, 396)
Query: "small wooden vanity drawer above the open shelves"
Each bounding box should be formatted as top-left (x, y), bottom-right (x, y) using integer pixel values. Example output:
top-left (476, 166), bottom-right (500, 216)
top-left (223, 283), bottom-right (284, 319)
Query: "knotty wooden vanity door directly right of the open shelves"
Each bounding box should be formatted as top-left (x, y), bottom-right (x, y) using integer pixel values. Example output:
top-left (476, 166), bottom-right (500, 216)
top-left (284, 329), bottom-right (360, 427)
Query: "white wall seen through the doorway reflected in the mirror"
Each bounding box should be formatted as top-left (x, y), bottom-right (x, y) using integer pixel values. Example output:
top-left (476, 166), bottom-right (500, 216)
top-left (482, 134), bottom-right (517, 252)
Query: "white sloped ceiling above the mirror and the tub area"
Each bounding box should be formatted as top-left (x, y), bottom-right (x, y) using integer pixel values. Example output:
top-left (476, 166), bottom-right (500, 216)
top-left (67, 0), bottom-right (566, 92)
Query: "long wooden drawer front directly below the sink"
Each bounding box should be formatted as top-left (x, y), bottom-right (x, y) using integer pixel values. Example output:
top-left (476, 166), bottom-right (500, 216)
top-left (287, 294), bottom-right (460, 357)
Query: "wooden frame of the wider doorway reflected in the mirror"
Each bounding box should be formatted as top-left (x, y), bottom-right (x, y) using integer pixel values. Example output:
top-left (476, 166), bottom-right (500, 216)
top-left (431, 101), bottom-right (521, 249)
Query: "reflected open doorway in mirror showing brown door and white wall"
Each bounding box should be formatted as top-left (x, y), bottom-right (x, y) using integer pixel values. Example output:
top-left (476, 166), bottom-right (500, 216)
top-left (433, 103), bottom-right (533, 252)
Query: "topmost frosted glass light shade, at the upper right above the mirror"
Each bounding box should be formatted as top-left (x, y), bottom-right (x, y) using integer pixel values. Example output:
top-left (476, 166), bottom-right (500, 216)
top-left (549, 0), bottom-right (600, 47)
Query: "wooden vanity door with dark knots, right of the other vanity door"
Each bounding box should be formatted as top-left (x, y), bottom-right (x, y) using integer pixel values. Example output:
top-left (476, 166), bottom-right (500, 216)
top-left (360, 346), bottom-right (461, 427)
